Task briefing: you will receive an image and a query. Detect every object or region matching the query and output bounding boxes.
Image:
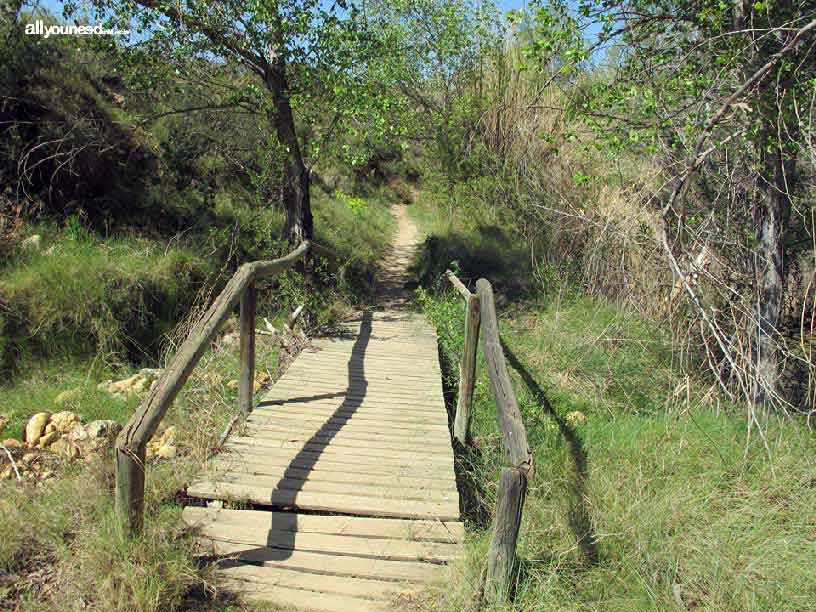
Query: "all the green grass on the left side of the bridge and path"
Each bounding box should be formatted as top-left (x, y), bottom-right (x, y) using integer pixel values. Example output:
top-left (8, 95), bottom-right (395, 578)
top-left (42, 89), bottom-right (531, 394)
top-left (0, 189), bottom-right (393, 611)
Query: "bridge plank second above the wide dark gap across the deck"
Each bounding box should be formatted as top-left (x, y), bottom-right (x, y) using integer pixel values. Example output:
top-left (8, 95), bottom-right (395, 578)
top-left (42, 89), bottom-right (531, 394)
top-left (188, 473), bottom-right (459, 503)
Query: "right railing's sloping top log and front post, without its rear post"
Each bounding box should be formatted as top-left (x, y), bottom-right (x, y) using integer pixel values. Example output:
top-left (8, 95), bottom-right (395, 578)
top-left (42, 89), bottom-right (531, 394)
top-left (476, 278), bottom-right (533, 600)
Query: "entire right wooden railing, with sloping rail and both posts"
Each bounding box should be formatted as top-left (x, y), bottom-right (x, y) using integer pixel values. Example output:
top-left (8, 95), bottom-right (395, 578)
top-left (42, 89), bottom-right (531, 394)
top-left (445, 270), bottom-right (533, 599)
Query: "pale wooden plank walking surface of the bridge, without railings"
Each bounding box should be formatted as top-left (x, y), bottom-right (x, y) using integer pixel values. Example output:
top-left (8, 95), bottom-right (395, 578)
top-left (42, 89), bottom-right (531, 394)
top-left (184, 310), bottom-right (464, 612)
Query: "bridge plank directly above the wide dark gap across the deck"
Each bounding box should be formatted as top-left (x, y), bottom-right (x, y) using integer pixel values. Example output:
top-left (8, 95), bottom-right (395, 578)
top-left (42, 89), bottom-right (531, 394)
top-left (187, 483), bottom-right (459, 521)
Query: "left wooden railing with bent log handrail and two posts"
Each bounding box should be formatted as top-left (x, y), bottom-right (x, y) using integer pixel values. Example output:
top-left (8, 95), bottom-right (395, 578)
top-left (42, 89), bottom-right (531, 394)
top-left (115, 241), bottom-right (336, 536)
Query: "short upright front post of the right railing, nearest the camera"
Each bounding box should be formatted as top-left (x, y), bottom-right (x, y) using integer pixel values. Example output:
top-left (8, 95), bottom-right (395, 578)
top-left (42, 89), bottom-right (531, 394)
top-left (486, 468), bottom-right (527, 601)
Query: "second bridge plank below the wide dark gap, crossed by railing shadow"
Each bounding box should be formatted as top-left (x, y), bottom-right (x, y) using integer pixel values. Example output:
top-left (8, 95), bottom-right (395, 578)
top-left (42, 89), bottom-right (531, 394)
top-left (186, 522), bottom-right (459, 563)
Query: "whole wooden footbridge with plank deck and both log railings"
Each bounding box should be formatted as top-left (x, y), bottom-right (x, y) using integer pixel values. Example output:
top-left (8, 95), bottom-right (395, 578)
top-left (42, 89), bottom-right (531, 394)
top-left (116, 212), bottom-right (531, 612)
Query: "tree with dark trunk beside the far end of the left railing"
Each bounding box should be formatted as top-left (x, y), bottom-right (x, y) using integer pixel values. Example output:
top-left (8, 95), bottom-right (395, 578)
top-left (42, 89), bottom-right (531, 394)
top-left (84, 0), bottom-right (390, 244)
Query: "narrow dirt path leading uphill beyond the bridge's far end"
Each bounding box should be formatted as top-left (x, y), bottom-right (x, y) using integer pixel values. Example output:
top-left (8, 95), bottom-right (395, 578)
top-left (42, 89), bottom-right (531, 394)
top-left (377, 204), bottom-right (422, 309)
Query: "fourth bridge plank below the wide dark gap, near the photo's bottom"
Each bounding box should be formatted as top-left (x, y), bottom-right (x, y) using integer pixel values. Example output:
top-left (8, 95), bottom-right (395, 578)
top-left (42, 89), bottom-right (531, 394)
top-left (218, 565), bottom-right (420, 605)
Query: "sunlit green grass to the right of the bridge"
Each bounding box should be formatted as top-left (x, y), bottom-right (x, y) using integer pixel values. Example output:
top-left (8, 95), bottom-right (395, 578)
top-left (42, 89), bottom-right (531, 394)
top-left (412, 195), bottom-right (816, 611)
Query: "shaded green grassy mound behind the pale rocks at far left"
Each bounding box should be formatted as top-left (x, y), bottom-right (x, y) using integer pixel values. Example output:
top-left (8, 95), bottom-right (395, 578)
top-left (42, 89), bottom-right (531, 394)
top-left (0, 226), bottom-right (214, 370)
